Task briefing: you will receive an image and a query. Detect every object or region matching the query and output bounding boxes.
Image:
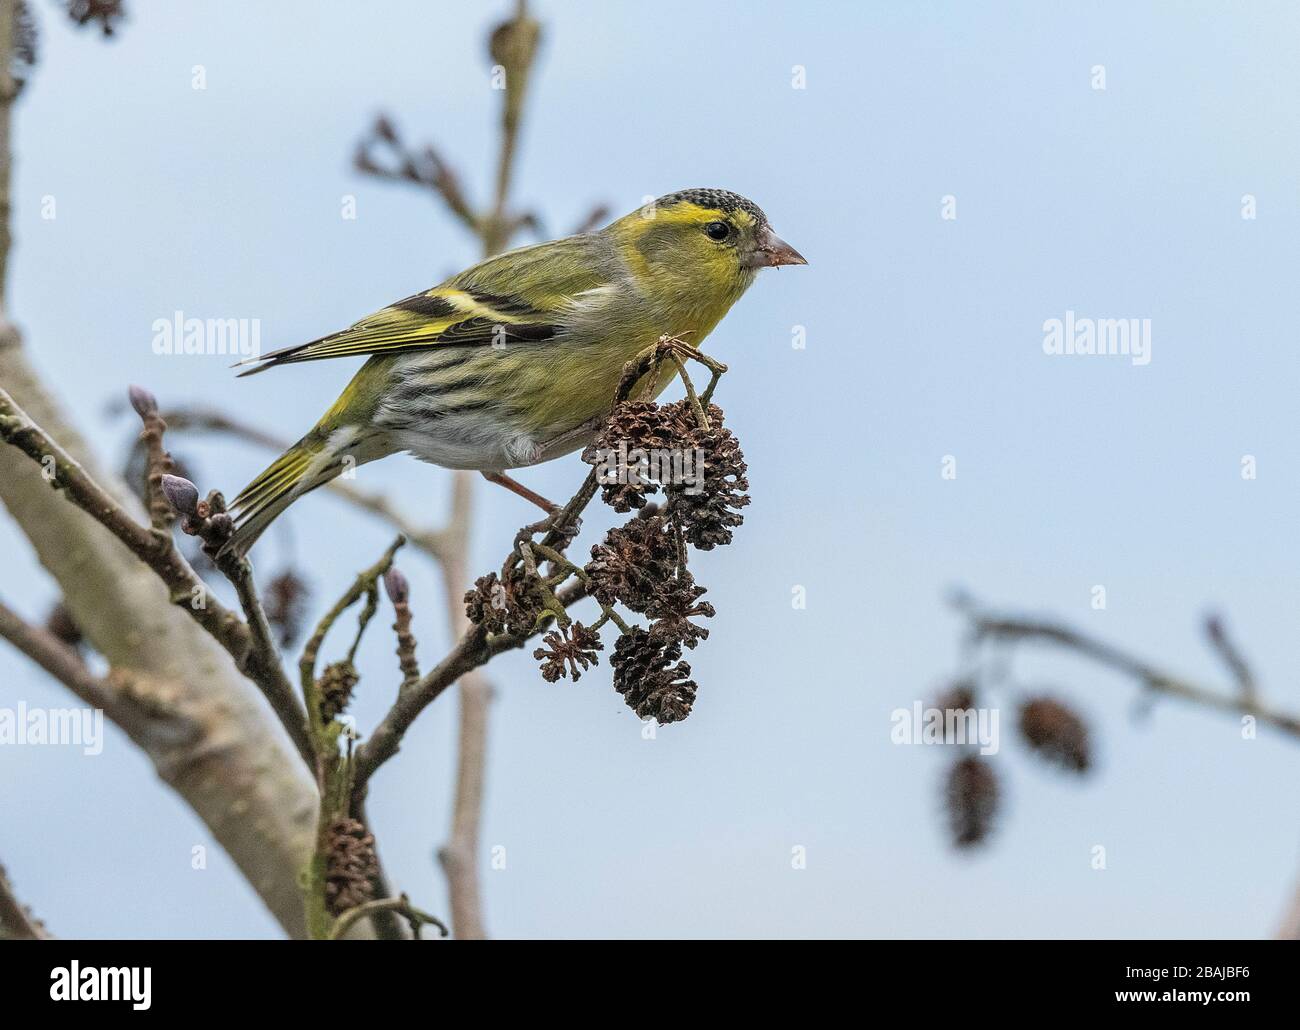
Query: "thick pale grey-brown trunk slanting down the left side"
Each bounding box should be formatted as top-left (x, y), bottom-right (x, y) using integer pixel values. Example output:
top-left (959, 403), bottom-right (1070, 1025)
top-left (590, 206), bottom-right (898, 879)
top-left (0, 0), bottom-right (325, 935)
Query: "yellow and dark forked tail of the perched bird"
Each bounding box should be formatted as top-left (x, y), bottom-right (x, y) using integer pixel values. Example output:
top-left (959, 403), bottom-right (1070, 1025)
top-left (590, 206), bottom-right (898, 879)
top-left (222, 424), bottom-right (382, 557)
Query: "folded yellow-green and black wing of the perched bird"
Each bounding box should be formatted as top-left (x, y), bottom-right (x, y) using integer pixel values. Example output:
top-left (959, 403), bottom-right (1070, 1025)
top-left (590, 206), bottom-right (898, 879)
top-left (239, 237), bottom-right (607, 376)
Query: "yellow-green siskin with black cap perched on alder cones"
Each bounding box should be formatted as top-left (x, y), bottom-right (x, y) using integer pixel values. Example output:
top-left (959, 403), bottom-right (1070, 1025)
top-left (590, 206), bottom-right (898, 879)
top-left (226, 190), bottom-right (807, 554)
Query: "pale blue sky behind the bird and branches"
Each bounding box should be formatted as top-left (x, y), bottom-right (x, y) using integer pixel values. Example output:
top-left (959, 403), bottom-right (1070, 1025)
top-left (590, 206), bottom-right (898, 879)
top-left (0, 0), bottom-right (1300, 936)
